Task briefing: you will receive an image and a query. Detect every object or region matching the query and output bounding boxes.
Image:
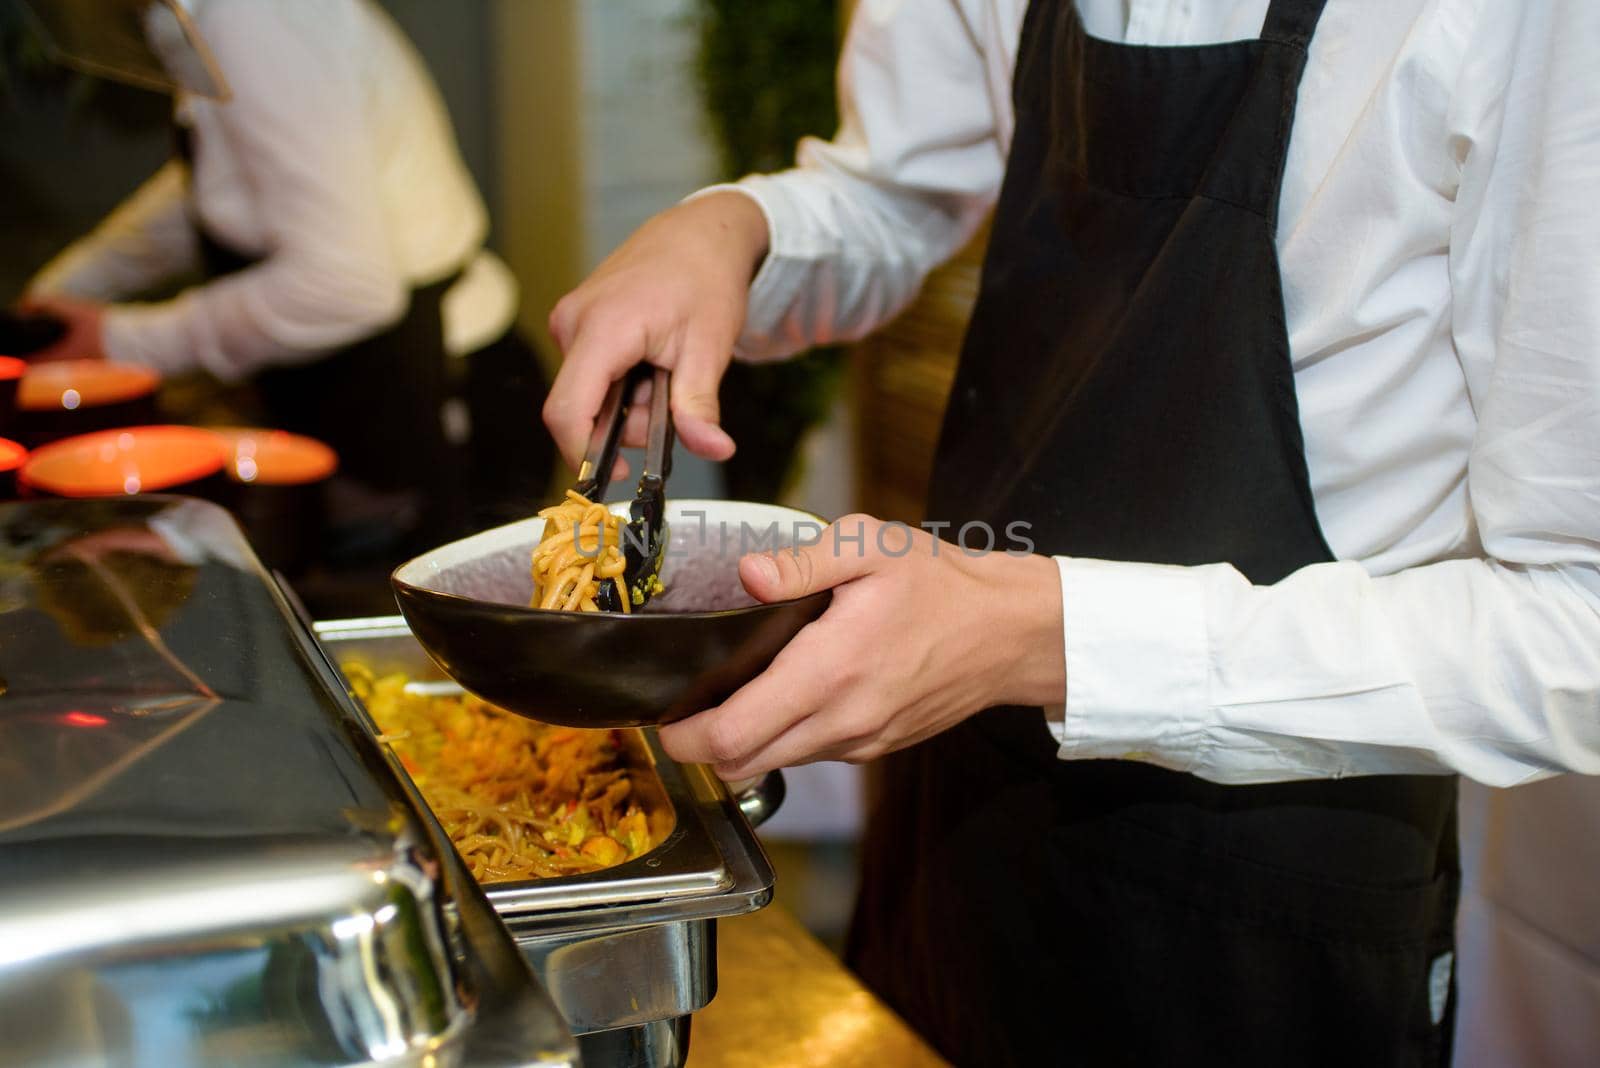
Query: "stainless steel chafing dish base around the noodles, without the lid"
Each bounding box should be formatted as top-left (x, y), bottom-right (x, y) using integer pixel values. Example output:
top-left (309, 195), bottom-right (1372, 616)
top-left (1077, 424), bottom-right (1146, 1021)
top-left (315, 617), bottom-right (782, 1065)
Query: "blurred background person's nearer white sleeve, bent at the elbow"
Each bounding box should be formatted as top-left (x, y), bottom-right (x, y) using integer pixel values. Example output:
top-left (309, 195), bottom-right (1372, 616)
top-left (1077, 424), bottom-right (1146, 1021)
top-left (106, 0), bottom-right (410, 379)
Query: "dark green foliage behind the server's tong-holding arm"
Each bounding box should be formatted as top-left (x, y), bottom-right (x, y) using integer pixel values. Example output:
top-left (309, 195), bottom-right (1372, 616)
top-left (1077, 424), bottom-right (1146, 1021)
top-left (698, 0), bottom-right (845, 500)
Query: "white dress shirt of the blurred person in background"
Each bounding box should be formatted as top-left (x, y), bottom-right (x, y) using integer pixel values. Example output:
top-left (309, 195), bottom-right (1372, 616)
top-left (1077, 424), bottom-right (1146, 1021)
top-left (30, 0), bottom-right (517, 379)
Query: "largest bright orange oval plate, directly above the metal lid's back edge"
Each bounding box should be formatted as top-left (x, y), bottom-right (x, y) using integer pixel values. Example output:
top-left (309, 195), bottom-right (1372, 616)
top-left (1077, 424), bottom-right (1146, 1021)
top-left (21, 427), bottom-right (229, 497)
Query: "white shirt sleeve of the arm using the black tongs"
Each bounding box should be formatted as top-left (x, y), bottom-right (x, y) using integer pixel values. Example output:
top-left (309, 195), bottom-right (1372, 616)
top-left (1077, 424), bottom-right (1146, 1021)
top-left (715, 0), bottom-right (1014, 360)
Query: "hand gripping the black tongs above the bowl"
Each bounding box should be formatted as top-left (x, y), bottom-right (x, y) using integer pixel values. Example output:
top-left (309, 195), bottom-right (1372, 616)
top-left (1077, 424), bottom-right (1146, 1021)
top-left (544, 192), bottom-right (766, 467)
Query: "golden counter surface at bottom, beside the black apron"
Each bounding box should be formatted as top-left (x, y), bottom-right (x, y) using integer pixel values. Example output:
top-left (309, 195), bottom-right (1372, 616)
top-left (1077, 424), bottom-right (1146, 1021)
top-left (688, 905), bottom-right (946, 1068)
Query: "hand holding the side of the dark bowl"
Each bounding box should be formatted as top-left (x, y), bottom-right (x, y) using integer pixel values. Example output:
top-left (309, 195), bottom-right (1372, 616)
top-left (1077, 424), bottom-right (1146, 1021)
top-left (661, 515), bottom-right (1066, 779)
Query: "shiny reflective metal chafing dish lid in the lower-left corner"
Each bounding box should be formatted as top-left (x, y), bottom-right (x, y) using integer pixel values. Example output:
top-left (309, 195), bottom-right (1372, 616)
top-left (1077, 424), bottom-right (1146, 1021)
top-left (0, 497), bottom-right (576, 1068)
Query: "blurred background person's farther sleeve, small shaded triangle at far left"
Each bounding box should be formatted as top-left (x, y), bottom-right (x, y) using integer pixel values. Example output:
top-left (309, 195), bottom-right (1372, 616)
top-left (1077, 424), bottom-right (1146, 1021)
top-left (27, 160), bottom-right (200, 301)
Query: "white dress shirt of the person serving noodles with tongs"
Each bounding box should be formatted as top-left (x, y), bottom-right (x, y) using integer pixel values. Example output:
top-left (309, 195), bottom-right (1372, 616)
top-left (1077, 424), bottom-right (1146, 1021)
top-left (720, 0), bottom-right (1600, 785)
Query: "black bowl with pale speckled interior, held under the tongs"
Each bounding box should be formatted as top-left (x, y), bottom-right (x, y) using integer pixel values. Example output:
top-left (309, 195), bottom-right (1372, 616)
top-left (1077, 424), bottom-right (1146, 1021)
top-left (392, 500), bottom-right (832, 727)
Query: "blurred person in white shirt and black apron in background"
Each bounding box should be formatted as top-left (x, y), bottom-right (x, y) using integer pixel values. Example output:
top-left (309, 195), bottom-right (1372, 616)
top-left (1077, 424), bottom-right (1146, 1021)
top-left (24, 0), bottom-right (554, 563)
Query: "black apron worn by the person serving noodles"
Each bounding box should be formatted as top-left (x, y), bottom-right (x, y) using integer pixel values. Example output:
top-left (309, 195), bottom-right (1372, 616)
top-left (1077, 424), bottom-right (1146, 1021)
top-left (850, 0), bottom-right (1458, 1068)
